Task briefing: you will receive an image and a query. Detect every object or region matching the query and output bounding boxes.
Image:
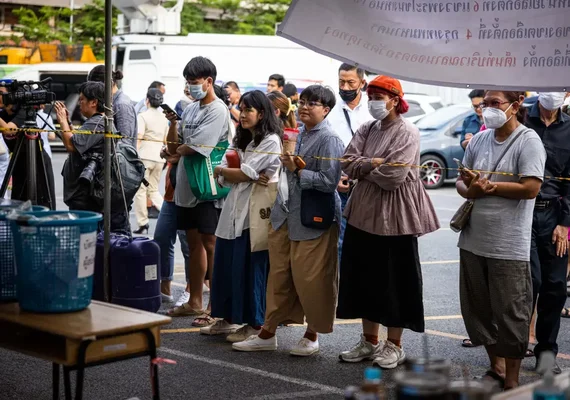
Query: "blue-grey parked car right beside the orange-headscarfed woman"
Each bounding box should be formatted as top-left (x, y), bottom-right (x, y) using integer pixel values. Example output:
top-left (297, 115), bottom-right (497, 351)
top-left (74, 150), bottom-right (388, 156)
top-left (416, 104), bottom-right (474, 189)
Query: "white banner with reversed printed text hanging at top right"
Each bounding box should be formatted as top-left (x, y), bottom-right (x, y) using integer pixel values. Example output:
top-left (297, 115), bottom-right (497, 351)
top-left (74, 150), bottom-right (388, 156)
top-left (278, 0), bottom-right (570, 91)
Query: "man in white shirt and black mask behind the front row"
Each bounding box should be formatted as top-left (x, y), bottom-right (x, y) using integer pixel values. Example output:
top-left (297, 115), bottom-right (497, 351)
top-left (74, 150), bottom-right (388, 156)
top-left (327, 63), bottom-right (373, 265)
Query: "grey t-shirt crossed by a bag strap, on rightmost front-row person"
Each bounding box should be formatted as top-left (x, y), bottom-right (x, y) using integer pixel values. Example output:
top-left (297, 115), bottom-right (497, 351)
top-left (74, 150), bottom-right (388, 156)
top-left (458, 125), bottom-right (546, 261)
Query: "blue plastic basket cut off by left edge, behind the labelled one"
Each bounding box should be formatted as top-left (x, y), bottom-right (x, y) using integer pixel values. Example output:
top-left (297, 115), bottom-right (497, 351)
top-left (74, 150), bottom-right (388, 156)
top-left (0, 199), bottom-right (48, 302)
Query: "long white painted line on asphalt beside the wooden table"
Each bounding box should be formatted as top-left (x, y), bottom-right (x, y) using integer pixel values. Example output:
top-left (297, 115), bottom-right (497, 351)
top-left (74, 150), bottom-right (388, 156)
top-left (158, 347), bottom-right (344, 395)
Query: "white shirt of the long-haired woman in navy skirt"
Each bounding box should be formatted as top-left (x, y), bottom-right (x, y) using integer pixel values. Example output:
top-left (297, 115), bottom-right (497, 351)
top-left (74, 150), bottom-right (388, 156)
top-left (216, 134), bottom-right (281, 240)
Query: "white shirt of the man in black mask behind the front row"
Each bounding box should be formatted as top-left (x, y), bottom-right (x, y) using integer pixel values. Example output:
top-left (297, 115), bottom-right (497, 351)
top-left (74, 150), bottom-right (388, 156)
top-left (327, 92), bottom-right (374, 147)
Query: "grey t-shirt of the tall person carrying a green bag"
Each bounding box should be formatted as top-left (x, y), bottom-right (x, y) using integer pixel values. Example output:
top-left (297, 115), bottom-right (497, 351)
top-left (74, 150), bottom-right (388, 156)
top-left (174, 98), bottom-right (230, 208)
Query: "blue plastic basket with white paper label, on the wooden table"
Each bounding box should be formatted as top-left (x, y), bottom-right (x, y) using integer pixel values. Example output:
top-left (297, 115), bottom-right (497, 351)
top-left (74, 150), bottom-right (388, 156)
top-left (10, 211), bottom-right (103, 313)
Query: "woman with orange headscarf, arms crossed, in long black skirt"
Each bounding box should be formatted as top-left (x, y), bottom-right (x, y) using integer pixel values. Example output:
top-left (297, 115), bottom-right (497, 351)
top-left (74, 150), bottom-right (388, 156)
top-left (337, 76), bottom-right (439, 369)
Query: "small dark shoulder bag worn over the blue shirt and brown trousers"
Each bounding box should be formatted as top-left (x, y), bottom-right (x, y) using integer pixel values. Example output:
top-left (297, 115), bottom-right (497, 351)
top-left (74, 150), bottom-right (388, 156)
top-left (301, 189), bottom-right (335, 230)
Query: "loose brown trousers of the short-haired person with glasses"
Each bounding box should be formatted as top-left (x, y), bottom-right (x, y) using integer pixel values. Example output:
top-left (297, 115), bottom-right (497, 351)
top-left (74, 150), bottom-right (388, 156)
top-left (265, 223), bottom-right (338, 333)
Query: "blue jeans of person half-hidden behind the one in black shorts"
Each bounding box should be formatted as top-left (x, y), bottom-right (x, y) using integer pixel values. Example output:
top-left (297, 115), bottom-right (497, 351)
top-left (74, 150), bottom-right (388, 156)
top-left (154, 201), bottom-right (190, 282)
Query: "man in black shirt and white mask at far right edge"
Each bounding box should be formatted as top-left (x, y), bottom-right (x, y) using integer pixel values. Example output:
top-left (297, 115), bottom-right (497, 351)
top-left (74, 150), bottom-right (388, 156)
top-left (525, 93), bottom-right (570, 373)
